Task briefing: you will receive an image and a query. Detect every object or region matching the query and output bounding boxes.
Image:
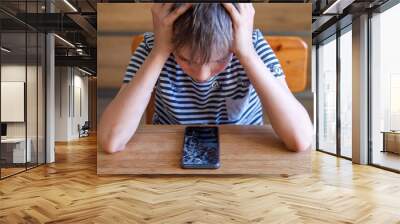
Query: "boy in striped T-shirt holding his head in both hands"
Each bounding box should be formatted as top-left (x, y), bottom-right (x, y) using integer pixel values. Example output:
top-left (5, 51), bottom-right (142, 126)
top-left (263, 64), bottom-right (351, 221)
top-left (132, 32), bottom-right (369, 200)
top-left (99, 3), bottom-right (313, 153)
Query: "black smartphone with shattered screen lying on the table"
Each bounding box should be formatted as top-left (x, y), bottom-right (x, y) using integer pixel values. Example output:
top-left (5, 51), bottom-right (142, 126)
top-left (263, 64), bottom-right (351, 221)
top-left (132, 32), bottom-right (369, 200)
top-left (181, 126), bottom-right (220, 169)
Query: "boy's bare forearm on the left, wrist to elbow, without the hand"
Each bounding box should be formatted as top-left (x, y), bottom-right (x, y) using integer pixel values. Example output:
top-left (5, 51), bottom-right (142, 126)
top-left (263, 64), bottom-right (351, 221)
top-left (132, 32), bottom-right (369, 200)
top-left (98, 49), bottom-right (169, 153)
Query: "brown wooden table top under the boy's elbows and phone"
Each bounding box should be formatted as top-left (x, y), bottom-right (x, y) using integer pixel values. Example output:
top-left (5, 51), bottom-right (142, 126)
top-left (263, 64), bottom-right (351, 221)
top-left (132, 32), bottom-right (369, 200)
top-left (97, 125), bottom-right (311, 175)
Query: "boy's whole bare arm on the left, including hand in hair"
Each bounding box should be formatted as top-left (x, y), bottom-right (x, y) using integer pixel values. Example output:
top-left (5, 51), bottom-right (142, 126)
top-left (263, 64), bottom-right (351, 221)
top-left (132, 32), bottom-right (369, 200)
top-left (98, 3), bottom-right (191, 153)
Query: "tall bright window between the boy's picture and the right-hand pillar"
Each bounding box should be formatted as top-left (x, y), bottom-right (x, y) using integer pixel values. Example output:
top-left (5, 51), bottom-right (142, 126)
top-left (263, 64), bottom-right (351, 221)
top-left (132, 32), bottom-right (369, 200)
top-left (317, 24), bottom-right (352, 158)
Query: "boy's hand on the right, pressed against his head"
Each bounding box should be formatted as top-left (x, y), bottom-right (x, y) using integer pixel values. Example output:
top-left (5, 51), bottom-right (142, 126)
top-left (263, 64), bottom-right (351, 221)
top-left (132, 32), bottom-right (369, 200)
top-left (222, 3), bottom-right (255, 57)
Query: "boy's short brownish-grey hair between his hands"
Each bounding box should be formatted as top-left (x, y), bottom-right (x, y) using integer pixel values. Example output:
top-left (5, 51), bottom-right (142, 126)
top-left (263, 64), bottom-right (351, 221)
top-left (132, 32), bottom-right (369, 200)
top-left (172, 3), bottom-right (238, 64)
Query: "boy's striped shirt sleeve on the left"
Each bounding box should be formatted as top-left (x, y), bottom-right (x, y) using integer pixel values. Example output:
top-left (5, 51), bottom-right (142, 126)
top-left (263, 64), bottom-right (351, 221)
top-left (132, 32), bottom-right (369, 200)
top-left (123, 33), bottom-right (154, 83)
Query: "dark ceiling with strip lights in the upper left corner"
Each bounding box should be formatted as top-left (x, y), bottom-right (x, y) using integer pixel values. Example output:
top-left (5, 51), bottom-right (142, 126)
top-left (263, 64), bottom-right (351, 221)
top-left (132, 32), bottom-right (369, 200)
top-left (0, 0), bottom-right (97, 73)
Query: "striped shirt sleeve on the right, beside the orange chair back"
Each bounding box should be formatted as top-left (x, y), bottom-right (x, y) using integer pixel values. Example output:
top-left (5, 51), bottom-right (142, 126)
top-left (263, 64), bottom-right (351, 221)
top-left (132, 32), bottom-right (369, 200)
top-left (253, 29), bottom-right (285, 78)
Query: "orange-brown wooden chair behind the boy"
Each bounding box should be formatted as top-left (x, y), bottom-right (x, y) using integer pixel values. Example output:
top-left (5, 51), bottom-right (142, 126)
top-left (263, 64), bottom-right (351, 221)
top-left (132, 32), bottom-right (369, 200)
top-left (131, 35), bottom-right (308, 124)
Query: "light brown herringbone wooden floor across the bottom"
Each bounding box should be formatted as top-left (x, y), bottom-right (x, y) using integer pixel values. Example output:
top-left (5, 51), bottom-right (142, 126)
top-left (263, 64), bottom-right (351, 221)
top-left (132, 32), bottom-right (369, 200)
top-left (0, 134), bottom-right (400, 224)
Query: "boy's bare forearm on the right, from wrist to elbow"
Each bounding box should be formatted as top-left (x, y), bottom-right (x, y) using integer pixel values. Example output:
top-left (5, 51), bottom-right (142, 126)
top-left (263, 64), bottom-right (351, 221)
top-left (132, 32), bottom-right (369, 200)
top-left (239, 51), bottom-right (313, 151)
